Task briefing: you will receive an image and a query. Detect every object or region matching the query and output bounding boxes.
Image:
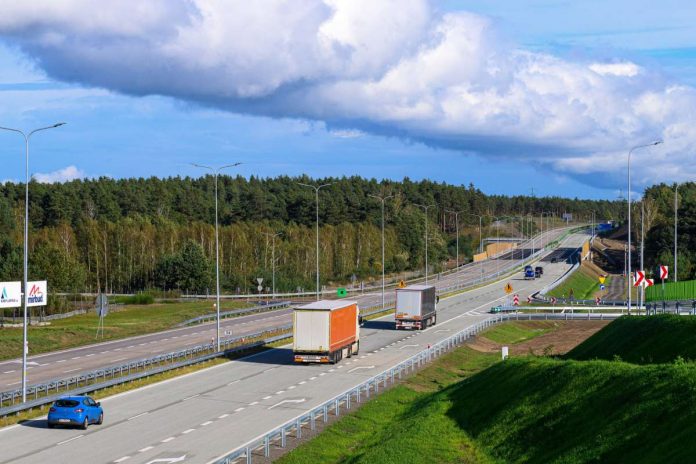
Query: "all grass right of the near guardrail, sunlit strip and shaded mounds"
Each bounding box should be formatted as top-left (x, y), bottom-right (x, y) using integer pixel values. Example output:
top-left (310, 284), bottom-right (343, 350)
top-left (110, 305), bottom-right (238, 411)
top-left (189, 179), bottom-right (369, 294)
top-left (279, 316), bottom-right (696, 464)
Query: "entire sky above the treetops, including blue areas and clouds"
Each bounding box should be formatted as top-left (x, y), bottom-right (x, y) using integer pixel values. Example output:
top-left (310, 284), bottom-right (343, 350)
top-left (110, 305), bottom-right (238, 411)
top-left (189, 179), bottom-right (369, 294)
top-left (0, 0), bottom-right (696, 199)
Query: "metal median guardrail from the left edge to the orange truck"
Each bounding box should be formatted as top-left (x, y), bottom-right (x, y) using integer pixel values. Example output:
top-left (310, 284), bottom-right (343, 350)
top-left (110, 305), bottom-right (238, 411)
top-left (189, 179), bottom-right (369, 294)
top-left (0, 325), bottom-right (292, 417)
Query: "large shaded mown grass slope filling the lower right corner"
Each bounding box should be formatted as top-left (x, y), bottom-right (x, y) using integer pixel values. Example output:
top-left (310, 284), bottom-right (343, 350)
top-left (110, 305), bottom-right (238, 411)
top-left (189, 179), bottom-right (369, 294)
top-left (448, 357), bottom-right (696, 463)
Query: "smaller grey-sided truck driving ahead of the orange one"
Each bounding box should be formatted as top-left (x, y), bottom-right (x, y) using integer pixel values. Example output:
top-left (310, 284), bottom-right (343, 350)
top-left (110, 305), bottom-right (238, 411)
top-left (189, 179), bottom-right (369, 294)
top-left (395, 285), bottom-right (438, 330)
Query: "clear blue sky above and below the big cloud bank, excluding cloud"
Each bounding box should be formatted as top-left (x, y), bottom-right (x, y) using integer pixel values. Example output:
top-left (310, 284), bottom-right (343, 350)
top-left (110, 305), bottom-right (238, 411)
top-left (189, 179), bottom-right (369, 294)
top-left (0, 0), bottom-right (696, 199)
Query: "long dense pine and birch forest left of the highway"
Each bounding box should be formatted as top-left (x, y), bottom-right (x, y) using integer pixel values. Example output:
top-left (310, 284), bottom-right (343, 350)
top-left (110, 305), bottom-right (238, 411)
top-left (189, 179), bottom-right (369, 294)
top-left (0, 176), bottom-right (620, 293)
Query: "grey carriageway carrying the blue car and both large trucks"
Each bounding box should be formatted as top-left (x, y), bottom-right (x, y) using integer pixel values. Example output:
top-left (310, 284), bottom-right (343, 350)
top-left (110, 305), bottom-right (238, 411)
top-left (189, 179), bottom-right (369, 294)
top-left (0, 230), bottom-right (586, 464)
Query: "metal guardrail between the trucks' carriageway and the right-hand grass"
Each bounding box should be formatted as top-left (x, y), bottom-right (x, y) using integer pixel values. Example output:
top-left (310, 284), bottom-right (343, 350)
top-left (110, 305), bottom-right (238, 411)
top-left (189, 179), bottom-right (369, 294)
top-left (211, 314), bottom-right (619, 464)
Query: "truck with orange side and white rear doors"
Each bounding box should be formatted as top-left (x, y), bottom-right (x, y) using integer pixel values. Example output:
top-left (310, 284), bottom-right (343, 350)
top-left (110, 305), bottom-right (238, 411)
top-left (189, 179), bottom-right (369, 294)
top-left (292, 300), bottom-right (360, 364)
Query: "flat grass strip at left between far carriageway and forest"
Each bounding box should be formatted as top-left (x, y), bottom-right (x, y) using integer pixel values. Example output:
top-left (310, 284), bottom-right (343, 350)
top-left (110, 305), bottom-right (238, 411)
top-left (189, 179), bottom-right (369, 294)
top-left (0, 301), bottom-right (249, 359)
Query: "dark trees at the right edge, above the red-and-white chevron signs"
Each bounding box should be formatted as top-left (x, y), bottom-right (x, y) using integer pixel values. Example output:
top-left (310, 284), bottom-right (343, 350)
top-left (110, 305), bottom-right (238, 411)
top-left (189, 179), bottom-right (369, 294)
top-left (632, 182), bottom-right (696, 280)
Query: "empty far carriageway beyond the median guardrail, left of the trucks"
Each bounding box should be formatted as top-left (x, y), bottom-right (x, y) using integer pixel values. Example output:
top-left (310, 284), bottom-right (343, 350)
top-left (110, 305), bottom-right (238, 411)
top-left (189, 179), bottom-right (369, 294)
top-left (0, 229), bottom-right (581, 391)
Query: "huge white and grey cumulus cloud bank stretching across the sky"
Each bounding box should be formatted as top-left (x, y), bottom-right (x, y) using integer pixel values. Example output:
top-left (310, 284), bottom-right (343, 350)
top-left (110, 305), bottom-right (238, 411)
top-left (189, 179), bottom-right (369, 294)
top-left (0, 0), bottom-right (696, 186)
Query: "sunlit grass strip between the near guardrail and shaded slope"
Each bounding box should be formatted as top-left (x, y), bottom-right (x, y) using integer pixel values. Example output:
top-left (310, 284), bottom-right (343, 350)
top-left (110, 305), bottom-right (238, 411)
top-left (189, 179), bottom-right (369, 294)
top-left (278, 322), bottom-right (551, 464)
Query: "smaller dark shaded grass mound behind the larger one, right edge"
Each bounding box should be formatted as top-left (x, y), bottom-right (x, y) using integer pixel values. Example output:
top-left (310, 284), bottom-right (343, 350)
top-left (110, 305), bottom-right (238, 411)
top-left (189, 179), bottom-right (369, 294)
top-left (566, 314), bottom-right (696, 364)
